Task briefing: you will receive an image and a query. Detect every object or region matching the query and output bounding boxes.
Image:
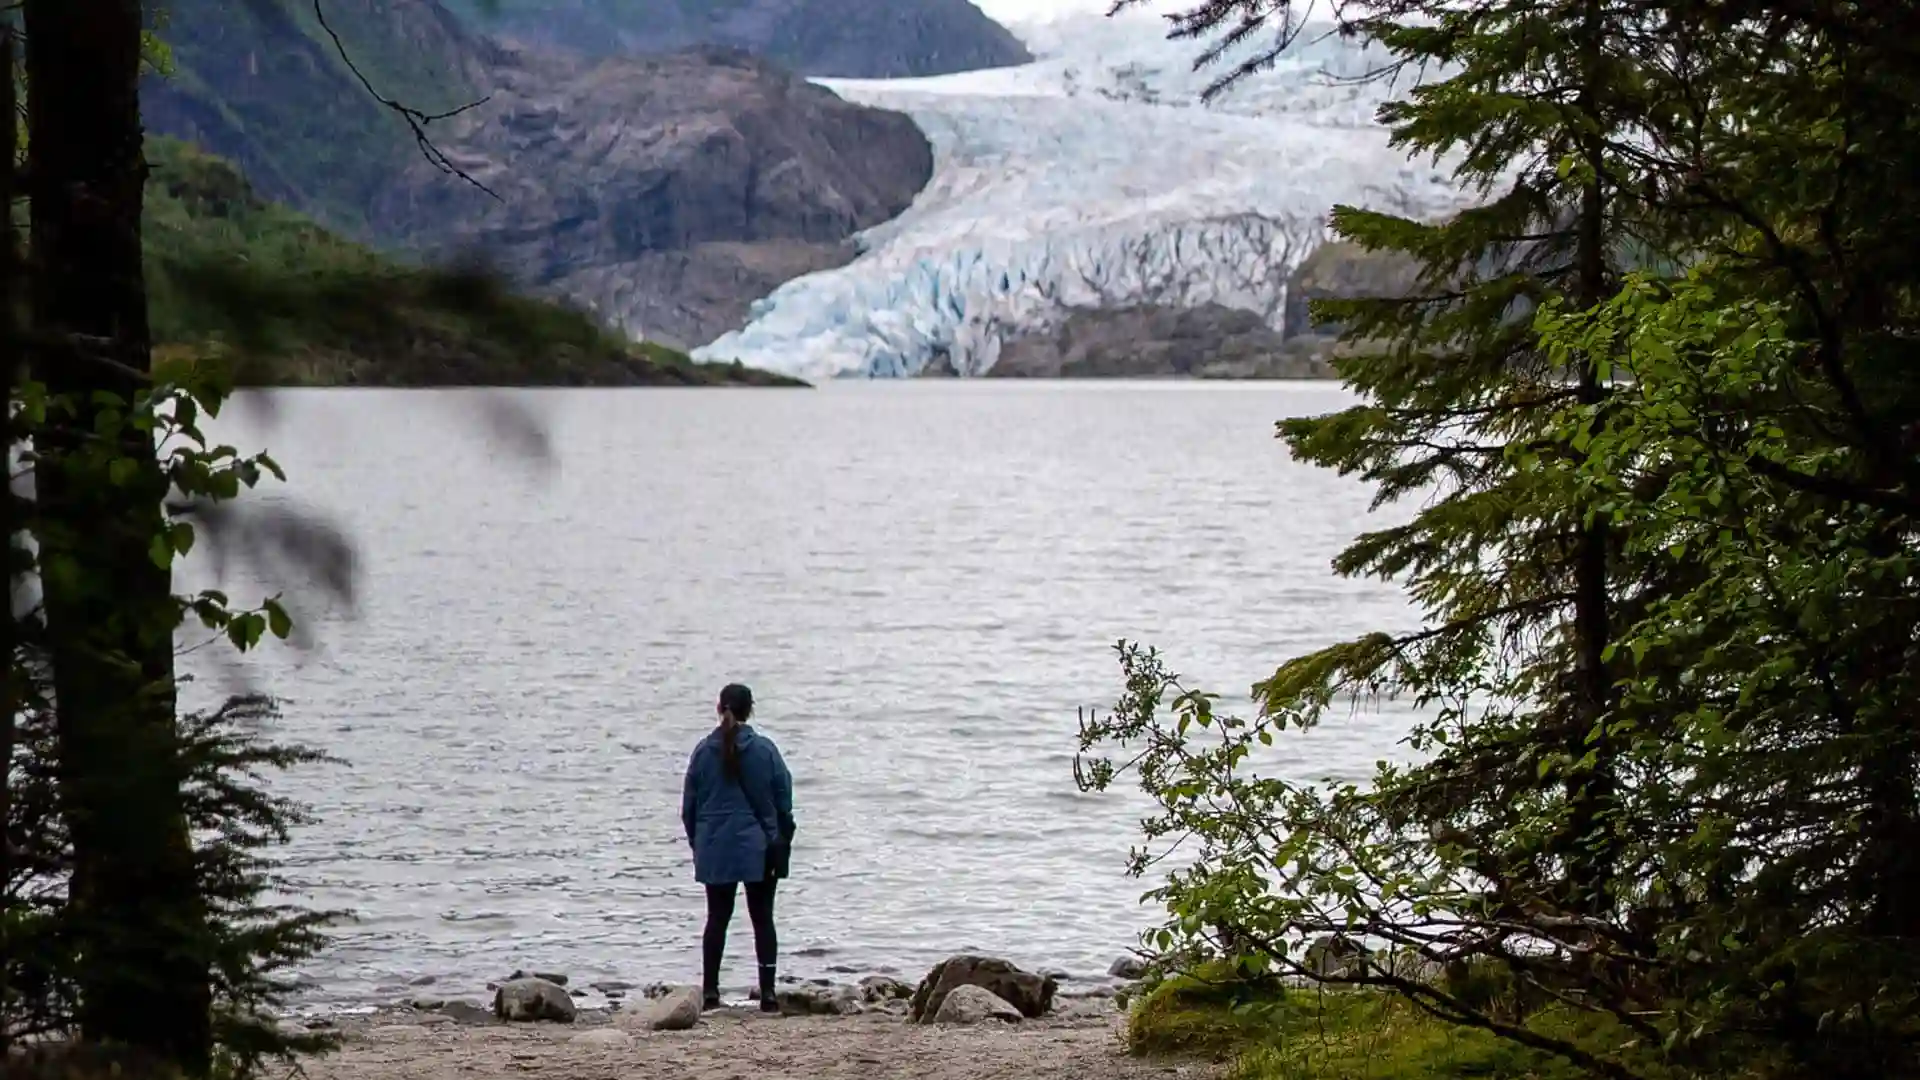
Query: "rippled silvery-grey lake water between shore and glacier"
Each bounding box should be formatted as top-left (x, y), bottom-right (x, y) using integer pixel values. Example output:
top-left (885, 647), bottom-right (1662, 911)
top-left (176, 382), bottom-right (1409, 1001)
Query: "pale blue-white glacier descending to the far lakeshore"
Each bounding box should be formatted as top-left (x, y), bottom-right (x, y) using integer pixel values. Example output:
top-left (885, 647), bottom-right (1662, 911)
top-left (693, 13), bottom-right (1471, 380)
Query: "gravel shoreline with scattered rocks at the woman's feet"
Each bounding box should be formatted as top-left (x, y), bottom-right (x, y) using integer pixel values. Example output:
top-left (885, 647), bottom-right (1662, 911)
top-left (282, 955), bottom-right (1159, 1080)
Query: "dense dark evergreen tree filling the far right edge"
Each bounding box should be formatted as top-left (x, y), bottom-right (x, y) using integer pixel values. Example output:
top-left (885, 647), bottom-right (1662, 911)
top-left (1520, 4), bottom-right (1920, 1076)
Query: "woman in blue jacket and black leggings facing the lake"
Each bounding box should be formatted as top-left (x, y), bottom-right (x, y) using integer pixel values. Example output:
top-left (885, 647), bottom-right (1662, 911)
top-left (680, 682), bottom-right (793, 1013)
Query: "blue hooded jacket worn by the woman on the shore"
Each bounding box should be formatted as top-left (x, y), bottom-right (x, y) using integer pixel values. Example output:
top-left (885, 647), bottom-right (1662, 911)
top-left (680, 724), bottom-right (793, 884)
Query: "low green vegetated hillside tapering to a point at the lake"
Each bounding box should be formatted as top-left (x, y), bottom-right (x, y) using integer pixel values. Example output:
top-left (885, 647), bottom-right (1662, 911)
top-left (144, 138), bottom-right (799, 386)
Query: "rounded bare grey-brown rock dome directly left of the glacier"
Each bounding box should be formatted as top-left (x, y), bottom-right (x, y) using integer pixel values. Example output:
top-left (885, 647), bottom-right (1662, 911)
top-left (371, 48), bottom-right (933, 346)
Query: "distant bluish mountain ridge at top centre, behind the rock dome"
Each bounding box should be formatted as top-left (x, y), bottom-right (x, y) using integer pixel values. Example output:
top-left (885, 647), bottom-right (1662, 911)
top-left (443, 0), bottom-right (1031, 79)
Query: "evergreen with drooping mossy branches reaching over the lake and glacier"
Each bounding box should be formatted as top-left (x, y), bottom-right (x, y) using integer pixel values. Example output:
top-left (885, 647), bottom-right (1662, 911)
top-left (1263, 0), bottom-right (1647, 915)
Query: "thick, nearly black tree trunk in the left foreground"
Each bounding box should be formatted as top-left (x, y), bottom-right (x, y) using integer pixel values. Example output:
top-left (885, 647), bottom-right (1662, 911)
top-left (23, 0), bottom-right (211, 1074)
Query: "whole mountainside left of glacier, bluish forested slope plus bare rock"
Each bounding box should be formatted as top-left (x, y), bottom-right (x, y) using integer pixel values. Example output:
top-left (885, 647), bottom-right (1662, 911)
top-left (142, 0), bottom-right (936, 348)
